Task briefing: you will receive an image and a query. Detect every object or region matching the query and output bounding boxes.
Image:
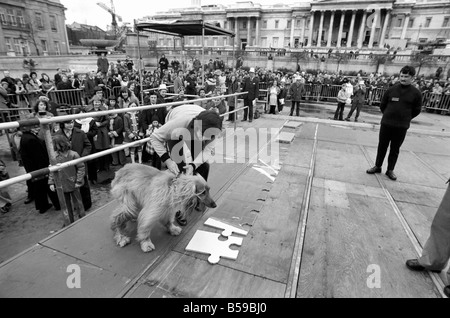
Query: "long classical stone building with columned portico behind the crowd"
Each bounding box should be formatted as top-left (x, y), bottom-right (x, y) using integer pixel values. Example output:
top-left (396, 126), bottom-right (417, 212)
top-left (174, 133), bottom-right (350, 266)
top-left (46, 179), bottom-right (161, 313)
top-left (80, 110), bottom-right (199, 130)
top-left (145, 0), bottom-right (450, 51)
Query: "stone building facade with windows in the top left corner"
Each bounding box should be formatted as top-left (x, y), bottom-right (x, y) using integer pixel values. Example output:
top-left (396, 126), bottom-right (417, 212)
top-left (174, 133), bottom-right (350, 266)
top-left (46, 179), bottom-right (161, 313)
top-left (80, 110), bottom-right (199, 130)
top-left (0, 0), bottom-right (69, 56)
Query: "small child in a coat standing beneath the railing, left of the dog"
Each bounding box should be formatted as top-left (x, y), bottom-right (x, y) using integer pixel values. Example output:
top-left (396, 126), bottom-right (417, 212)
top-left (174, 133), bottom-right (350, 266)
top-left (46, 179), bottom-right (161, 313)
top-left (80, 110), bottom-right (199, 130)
top-left (48, 135), bottom-right (85, 218)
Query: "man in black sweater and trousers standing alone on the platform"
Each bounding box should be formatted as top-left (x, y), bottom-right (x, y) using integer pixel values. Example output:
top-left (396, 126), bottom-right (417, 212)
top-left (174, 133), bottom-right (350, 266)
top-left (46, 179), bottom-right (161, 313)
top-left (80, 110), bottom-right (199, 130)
top-left (367, 66), bottom-right (422, 180)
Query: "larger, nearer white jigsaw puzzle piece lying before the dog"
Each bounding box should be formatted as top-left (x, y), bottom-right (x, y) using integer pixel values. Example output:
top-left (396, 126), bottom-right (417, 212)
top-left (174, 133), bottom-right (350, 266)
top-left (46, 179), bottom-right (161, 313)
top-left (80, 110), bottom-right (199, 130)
top-left (186, 230), bottom-right (243, 264)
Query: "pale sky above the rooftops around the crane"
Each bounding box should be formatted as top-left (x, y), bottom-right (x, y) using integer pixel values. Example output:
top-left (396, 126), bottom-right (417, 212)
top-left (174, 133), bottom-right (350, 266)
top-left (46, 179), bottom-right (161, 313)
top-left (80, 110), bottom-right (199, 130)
top-left (60, 0), bottom-right (300, 31)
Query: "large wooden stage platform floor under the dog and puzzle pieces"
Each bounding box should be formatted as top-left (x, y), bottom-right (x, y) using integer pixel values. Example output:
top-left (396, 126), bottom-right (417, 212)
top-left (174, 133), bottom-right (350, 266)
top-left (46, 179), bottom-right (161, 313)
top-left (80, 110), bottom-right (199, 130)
top-left (0, 116), bottom-right (450, 298)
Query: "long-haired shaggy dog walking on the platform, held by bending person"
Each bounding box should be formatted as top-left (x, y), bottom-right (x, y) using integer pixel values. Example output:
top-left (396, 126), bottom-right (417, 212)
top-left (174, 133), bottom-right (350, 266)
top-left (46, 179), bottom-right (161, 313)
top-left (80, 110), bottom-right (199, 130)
top-left (111, 164), bottom-right (216, 252)
